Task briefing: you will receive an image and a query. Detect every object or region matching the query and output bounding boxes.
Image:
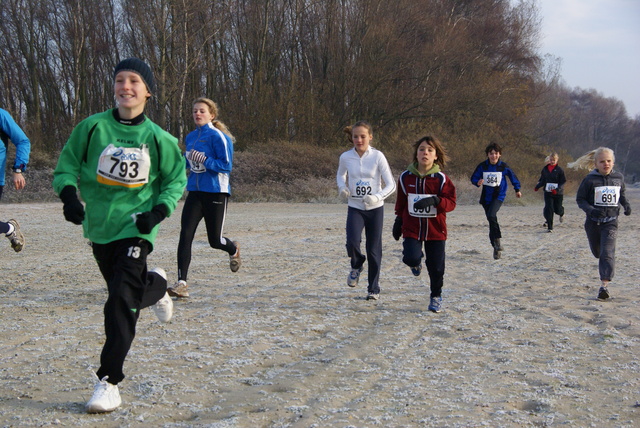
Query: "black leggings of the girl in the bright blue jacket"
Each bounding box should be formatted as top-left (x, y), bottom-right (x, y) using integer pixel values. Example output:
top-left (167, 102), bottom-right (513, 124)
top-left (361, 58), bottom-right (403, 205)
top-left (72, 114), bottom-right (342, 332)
top-left (178, 191), bottom-right (236, 281)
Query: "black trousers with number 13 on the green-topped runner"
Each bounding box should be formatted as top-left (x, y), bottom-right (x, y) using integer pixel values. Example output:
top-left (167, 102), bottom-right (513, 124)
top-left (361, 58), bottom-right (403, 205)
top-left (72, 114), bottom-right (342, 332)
top-left (92, 238), bottom-right (167, 384)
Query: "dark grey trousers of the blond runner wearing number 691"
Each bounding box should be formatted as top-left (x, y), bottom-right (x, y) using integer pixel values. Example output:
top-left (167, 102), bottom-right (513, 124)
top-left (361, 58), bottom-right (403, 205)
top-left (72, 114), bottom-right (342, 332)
top-left (584, 219), bottom-right (618, 281)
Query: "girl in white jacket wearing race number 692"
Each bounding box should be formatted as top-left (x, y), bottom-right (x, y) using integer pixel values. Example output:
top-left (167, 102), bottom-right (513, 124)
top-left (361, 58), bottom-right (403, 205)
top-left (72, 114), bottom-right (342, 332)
top-left (336, 121), bottom-right (396, 300)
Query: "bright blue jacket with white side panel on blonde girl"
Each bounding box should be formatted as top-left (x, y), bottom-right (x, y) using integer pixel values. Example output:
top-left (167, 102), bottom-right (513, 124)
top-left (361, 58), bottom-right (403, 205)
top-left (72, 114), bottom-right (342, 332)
top-left (185, 123), bottom-right (233, 195)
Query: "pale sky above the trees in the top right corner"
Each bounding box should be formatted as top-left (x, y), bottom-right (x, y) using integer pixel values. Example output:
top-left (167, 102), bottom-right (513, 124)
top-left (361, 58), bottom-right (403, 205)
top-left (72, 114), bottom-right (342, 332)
top-left (537, 0), bottom-right (640, 118)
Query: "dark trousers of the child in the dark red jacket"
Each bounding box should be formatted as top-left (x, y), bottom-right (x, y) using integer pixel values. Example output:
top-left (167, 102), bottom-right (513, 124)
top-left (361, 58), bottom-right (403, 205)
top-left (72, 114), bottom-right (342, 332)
top-left (402, 238), bottom-right (447, 297)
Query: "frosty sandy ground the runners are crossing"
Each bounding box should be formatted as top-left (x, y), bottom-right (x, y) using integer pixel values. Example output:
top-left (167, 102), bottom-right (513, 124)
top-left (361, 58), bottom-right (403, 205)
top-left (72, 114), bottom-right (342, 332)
top-left (0, 189), bottom-right (640, 427)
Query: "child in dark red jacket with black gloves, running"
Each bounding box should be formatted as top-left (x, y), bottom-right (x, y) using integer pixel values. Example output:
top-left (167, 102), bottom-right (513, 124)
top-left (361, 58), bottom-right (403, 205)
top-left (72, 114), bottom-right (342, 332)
top-left (393, 135), bottom-right (456, 312)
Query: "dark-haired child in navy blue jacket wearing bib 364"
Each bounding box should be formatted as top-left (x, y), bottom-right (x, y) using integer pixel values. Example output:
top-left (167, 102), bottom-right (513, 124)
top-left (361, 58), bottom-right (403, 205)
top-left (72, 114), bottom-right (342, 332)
top-left (471, 142), bottom-right (522, 260)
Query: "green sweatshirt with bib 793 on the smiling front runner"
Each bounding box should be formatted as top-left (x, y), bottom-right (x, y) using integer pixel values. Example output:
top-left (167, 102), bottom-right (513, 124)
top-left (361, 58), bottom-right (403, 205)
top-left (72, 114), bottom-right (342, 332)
top-left (53, 110), bottom-right (187, 245)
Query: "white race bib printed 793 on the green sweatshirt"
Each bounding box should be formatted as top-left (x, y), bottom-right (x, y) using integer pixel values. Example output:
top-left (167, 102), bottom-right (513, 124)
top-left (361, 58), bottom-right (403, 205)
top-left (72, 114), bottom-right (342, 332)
top-left (97, 144), bottom-right (151, 188)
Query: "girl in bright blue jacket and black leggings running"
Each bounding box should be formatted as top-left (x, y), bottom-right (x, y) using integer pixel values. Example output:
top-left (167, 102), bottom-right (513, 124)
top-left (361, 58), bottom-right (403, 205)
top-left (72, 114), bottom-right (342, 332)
top-left (169, 97), bottom-right (241, 297)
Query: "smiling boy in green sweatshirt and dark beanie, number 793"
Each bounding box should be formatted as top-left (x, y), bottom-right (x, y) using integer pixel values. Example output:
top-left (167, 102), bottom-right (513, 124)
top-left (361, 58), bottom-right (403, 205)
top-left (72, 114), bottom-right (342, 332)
top-left (53, 58), bottom-right (187, 413)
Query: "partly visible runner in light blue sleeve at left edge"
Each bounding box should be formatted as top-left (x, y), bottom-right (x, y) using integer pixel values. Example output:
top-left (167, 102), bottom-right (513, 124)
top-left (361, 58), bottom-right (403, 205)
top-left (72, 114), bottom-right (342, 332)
top-left (0, 108), bottom-right (31, 253)
